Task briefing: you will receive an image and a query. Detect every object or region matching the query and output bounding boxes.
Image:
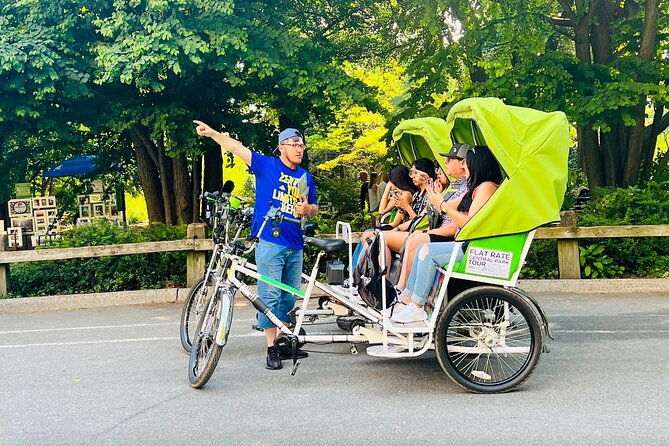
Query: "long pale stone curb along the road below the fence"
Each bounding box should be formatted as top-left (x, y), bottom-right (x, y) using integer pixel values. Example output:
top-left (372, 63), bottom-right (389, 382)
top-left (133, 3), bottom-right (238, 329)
top-left (0, 279), bottom-right (669, 314)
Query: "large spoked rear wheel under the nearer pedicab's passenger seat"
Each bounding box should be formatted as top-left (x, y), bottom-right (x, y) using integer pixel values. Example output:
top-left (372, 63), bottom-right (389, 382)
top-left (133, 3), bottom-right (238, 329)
top-left (434, 286), bottom-right (543, 393)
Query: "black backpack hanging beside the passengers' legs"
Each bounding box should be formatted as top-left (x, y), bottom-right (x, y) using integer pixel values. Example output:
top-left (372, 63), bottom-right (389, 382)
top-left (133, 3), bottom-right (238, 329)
top-left (353, 231), bottom-right (397, 310)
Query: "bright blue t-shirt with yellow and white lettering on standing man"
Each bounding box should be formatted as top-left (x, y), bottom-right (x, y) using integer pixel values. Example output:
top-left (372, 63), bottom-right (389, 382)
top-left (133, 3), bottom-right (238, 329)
top-left (251, 152), bottom-right (318, 249)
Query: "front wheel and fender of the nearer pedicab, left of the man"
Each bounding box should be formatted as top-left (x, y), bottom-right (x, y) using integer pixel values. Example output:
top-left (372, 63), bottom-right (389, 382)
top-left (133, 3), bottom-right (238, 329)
top-left (188, 287), bottom-right (236, 389)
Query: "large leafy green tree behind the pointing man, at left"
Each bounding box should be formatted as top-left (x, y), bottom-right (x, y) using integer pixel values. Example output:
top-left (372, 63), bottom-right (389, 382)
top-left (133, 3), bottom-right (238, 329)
top-left (0, 0), bottom-right (386, 223)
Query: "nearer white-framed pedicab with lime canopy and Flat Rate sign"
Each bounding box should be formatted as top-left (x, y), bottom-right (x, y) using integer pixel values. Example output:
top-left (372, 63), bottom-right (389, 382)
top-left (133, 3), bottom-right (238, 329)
top-left (189, 98), bottom-right (569, 393)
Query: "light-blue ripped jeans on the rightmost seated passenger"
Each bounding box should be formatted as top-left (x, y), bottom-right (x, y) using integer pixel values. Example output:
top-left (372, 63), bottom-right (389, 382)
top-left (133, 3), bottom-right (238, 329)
top-left (400, 242), bottom-right (463, 305)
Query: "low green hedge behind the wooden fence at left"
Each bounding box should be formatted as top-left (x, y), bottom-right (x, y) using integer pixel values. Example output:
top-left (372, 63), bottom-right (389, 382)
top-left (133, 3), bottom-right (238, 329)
top-left (9, 221), bottom-right (186, 297)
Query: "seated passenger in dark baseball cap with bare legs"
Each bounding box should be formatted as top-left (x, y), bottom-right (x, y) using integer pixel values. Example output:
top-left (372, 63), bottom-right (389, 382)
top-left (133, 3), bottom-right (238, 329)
top-left (397, 143), bottom-right (469, 290)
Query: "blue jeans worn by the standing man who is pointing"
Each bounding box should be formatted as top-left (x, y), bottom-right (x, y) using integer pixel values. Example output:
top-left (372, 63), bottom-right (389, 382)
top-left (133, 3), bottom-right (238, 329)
top-left (255, 240), bottom-right (302, 328)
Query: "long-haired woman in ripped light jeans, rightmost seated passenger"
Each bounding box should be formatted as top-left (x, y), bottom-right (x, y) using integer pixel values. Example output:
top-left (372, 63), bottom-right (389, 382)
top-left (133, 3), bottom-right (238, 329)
top-left (389, 146), bottom-right (502, 323)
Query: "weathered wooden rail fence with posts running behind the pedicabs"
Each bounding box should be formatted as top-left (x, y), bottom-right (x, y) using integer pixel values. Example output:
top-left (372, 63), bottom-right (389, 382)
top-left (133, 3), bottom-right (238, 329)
top-left (0, 215), bottom-right (669, 296)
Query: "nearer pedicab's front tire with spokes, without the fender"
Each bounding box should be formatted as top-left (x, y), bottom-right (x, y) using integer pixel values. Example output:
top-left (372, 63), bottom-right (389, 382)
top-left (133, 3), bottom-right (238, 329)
top-left (188, 297), bottom-right (222, 389)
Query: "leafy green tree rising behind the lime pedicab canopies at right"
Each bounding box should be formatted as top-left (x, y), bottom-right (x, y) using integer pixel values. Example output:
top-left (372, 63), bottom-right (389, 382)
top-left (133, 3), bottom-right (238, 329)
top-left (388, 0), bottom-right (669, 187)
